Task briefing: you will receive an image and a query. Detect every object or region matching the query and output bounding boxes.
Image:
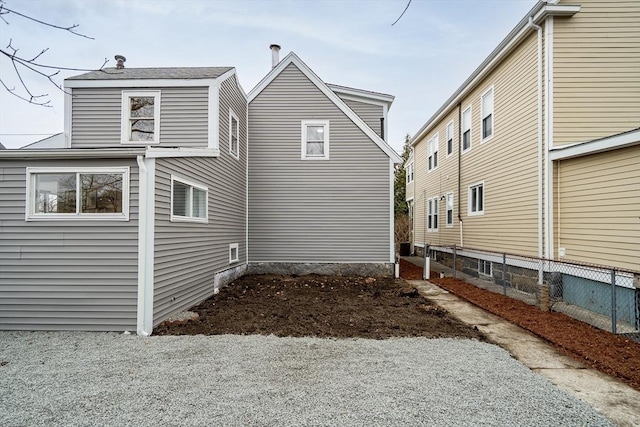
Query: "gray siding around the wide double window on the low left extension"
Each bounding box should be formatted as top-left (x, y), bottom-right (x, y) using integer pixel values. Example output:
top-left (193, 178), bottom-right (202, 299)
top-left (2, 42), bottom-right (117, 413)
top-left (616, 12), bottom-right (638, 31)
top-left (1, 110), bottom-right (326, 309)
top-left (0, 159), bottom-right (138, 331)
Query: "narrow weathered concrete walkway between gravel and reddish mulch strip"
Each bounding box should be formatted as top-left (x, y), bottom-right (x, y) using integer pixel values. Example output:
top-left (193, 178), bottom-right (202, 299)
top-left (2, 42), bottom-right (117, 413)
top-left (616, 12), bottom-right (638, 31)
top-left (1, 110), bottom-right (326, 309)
top-left (408, 280), bottom-right (640, 426)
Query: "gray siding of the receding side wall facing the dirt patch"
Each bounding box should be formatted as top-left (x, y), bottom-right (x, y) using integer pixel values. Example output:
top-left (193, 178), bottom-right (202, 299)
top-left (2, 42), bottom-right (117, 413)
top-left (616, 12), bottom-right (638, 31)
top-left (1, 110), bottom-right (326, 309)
top-left (154, 77), bottom-right (247, 325)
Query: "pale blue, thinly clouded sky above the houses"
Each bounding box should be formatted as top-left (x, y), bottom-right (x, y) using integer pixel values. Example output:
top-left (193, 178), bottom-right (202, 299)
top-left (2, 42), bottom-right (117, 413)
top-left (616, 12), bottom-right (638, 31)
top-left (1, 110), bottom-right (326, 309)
top-left (0, 0), bottom-right (535, 150)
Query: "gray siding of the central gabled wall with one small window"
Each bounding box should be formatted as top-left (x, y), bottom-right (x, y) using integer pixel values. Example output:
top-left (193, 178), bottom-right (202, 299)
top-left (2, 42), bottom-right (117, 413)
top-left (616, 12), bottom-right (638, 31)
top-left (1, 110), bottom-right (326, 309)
top-left (249, 64), bottom-right (390, 262)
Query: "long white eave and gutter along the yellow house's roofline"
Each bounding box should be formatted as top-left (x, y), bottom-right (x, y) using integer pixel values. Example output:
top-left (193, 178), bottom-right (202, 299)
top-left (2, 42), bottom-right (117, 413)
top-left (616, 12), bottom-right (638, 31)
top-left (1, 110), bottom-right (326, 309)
top-left (409, 1), bottom-right (580, 146)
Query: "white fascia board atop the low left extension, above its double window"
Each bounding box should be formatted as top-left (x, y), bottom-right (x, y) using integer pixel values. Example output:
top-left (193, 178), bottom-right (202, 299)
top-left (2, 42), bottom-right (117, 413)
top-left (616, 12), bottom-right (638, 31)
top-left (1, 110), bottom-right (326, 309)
top-left (0, 148), bottom-right (145, 159)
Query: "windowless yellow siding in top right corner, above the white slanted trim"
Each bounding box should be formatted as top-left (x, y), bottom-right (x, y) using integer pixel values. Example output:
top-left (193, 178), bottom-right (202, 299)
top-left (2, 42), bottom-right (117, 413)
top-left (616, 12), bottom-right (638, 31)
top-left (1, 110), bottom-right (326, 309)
top-left (553, 0), bottom-right (640, 145)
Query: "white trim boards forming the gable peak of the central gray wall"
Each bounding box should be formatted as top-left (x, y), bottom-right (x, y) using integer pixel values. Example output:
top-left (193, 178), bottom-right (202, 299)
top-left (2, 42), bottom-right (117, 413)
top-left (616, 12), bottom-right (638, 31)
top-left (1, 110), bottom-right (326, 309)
top-left (248, 52), bottom-right (402, 163)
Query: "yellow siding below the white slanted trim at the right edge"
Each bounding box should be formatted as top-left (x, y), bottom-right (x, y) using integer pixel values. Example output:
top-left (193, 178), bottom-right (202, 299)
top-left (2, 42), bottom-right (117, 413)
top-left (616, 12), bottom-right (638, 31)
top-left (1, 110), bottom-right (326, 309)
top-left (557, 145), bottom-right (640, 271)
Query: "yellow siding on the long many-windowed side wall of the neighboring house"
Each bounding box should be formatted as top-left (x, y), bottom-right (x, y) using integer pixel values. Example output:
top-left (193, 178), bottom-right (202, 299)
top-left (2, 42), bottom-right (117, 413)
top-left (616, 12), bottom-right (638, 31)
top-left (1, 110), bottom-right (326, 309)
top-left (414, 32), bottom-right (538, 256)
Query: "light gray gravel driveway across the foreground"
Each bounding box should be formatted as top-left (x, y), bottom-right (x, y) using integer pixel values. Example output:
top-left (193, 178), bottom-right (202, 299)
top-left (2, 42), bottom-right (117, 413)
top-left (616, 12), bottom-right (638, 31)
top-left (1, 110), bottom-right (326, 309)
top-left (0, 332), bottom-right (611, 427)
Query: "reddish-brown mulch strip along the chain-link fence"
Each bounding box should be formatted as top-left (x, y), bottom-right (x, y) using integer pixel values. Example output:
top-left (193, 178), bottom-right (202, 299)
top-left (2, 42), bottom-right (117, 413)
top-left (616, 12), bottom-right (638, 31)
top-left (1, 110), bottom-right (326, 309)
top-left (400, 260), bottom-right (640, 390)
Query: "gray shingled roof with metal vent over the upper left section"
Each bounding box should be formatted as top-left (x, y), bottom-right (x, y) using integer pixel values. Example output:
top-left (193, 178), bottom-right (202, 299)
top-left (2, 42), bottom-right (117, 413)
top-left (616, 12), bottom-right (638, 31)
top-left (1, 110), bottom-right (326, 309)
top-left (66, 67), bottom-right (233, 80)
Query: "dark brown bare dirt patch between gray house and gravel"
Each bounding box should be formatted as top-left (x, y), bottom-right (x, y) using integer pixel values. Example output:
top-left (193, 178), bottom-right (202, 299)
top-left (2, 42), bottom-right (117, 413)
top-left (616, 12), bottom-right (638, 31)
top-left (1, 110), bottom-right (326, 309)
top-left (154, 275), bottom-right (485, 340)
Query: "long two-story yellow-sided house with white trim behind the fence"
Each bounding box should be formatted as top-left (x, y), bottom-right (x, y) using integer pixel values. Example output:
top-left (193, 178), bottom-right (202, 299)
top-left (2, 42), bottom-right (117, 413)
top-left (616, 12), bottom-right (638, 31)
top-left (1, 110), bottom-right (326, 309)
top-left (407, 0), bottom-right (640, 272)
